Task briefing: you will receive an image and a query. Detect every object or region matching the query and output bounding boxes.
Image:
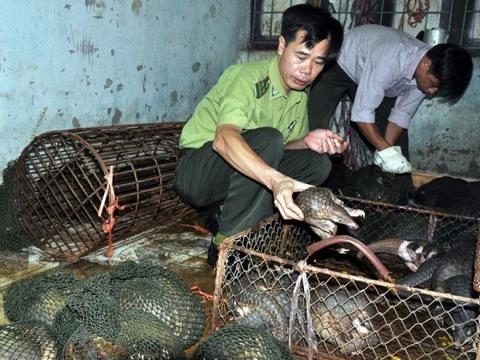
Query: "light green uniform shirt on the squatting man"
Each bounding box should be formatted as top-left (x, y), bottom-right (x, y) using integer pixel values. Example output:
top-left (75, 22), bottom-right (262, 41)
top-left (180, 56), bottom-right (308, 149)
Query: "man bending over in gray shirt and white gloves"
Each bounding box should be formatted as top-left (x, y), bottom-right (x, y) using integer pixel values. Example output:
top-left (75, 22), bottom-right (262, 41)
top-left (308, 25), bottom-right (473, 173)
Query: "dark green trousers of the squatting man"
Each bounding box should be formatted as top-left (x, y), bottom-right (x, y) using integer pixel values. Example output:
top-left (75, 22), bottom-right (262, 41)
top-left (175, 128), bottom-right (331, 236)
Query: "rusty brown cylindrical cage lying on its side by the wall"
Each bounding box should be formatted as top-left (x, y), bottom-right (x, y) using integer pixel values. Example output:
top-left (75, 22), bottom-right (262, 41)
top-left (15, 123), bottom-right (194, 262)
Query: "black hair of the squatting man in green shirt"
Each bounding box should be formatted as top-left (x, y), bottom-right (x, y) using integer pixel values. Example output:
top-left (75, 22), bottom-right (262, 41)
top-left (281, 4), bottom-right (343, 60)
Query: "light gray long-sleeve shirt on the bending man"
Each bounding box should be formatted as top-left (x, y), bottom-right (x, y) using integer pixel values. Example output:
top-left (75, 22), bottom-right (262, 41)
top-left (338, 25), bottom-right (430, 129)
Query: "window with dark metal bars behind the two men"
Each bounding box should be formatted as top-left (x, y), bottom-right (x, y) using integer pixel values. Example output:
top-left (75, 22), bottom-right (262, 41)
top-left (250, 0), bottom-right (480, 55)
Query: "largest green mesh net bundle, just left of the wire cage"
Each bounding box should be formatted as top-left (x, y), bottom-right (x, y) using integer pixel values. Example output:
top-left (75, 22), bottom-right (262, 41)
top-left (49, 261), bottom-right (206, 360)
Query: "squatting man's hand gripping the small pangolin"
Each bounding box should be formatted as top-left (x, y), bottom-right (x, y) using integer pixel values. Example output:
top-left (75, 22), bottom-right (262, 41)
top-left (272, 173), bottom-right (313, 221)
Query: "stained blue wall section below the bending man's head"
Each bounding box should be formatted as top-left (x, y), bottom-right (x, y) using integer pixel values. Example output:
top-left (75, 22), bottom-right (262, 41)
top-left (409, 58), bottom-right (480, 179)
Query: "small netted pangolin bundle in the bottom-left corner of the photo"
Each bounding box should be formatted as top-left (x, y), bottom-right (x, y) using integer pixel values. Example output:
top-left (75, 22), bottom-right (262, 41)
top-left (0, 321), bottom-right (58, 360)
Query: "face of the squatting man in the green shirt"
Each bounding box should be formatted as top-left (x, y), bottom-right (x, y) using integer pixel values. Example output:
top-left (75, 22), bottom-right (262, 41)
top-left (278, 31), bottom-right (330, 93)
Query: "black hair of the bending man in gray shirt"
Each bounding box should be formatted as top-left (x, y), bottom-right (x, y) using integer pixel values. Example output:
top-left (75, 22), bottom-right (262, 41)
top-left (426, 44), bottom-right (473, 104)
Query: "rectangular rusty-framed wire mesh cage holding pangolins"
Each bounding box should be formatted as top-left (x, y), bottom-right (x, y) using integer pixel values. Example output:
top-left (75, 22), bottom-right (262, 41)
top-left (211, 198), bottom-right (480, 360)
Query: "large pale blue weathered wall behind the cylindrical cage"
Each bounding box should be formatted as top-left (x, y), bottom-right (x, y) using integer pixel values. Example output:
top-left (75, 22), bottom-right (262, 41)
top-left (0, 0), bottom-right (249, 174)
